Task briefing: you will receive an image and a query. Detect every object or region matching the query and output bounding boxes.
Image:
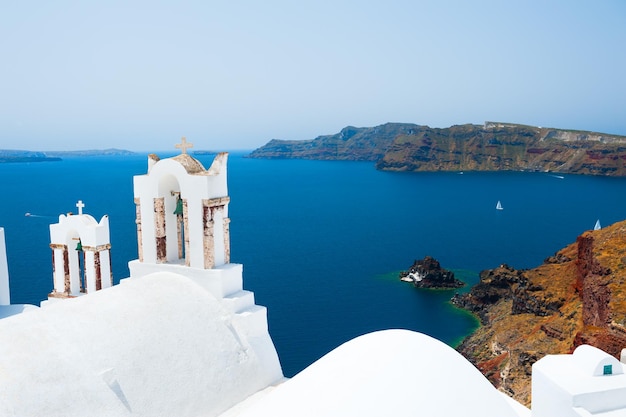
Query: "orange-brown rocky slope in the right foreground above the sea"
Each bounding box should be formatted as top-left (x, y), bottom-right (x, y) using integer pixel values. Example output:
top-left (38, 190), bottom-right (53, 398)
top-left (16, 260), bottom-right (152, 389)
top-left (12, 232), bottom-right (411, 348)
top-left (453, 221), bottom-right (626, 404)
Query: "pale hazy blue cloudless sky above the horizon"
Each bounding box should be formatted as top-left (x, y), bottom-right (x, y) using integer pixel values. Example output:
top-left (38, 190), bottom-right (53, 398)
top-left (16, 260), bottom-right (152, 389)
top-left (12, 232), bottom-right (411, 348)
top-left (0, 0), bottom-right (626, 151)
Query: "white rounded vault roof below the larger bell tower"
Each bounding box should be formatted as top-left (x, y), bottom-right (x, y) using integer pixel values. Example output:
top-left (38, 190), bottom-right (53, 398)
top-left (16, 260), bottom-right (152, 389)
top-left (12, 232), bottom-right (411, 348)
top-left (0, 273), bottom-right (282, 416)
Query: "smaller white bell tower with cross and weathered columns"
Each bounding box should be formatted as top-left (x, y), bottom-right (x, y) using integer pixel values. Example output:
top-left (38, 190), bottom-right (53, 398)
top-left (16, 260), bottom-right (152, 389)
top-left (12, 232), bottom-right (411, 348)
top-left (48, 200), bottom-right (113, 299)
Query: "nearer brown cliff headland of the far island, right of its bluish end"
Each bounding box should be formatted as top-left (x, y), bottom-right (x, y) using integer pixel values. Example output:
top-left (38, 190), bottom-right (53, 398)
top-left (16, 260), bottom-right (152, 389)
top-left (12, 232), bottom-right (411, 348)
top-left (377, 122), bottom-right (626, 176)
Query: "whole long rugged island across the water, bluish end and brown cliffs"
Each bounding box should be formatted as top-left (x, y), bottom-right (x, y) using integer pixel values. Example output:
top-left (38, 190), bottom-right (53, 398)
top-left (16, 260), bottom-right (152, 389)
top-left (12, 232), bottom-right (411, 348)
top-left (248, 122), bottom-right (626, 176)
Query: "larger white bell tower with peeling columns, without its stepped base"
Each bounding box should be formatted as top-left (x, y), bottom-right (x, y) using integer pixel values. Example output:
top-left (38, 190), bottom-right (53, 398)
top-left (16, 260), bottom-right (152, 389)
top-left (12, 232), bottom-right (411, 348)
top-left (131, 137), bottom-right (230, 275)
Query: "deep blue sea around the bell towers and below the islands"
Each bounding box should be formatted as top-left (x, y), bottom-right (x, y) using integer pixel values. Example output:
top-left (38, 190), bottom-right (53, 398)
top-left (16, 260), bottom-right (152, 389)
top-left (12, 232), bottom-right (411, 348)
top-left (0, 153), bottom-right (626, 376)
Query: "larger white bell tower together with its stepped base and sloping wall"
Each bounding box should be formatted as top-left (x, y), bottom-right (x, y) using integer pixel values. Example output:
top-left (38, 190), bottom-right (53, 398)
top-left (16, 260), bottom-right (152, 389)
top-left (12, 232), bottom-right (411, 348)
top-left (128, 141), bottom-right (282, 364)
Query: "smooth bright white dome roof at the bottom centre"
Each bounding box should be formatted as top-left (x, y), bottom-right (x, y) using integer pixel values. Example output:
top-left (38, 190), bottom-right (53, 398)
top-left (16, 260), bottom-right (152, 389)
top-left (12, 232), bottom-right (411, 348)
top-left (224, 330), bottom-right (529, 417)
